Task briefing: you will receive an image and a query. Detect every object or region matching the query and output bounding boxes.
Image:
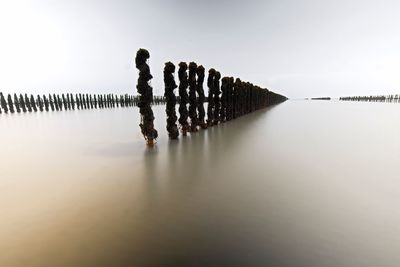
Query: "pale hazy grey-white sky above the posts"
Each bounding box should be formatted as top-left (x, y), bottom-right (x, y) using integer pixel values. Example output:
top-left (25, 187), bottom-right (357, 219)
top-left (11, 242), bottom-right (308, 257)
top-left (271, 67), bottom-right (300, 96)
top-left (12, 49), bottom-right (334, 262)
top-left (0, 0), bottom-right (400, 98)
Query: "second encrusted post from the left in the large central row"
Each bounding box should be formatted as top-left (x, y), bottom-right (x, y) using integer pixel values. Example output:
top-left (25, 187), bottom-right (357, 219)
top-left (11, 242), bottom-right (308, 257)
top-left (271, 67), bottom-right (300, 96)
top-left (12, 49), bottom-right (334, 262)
top-left (164, 62), bottom-right (179, 139)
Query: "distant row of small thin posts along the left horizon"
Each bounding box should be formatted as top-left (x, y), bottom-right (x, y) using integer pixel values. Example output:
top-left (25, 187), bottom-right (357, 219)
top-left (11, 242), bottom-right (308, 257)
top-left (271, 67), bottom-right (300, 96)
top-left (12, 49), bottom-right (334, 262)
top-left (0, 92), bottom-right (165, 114)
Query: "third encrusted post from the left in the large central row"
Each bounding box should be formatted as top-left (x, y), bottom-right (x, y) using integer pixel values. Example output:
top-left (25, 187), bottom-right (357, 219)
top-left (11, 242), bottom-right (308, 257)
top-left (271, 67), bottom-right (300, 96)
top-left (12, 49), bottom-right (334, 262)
top-left (178, 62), bottom-right (189, 136)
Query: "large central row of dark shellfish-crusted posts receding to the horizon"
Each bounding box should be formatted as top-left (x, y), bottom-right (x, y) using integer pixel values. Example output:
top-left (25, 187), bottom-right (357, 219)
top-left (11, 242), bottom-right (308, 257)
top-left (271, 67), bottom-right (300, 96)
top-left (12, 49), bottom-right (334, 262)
top-left (135, 48), bottom-right (287, 145)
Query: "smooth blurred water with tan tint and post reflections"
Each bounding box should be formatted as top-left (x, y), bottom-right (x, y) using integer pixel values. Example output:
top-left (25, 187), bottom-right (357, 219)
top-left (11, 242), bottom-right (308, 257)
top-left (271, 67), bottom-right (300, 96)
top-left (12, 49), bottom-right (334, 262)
top-left (0, 101), bottom-right (400, 267)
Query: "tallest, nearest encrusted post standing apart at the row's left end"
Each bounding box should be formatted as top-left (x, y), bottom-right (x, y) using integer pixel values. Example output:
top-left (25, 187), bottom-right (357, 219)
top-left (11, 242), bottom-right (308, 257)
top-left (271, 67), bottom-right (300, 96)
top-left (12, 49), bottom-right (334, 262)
top-left (135, 48), bottom-right (158, 146)
